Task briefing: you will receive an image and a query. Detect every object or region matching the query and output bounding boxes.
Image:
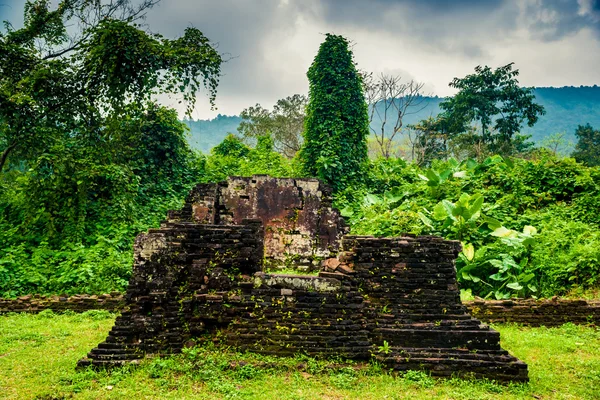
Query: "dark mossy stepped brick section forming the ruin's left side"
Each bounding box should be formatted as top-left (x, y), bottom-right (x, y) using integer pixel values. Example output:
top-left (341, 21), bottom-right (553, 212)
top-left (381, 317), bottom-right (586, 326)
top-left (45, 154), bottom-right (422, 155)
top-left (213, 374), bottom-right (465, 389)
top-left (79, 221), bottom-right (263, 366)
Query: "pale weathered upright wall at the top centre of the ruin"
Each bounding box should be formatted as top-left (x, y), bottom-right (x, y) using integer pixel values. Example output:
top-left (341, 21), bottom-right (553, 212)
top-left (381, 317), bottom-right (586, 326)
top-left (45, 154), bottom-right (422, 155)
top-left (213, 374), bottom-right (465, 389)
top-left (169, 175), bottom-right (347, 270)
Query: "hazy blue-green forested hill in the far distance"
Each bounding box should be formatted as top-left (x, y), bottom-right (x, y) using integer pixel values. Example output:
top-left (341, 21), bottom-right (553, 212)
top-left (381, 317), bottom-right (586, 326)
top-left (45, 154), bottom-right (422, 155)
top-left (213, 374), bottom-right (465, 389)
top-left (185, 85), bottom-right (600, 153)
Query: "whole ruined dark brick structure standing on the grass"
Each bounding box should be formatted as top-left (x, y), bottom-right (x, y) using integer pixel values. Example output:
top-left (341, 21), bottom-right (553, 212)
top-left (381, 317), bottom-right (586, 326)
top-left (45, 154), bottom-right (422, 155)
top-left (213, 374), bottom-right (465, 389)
top-left (78, 176), bottom-right (528, 381)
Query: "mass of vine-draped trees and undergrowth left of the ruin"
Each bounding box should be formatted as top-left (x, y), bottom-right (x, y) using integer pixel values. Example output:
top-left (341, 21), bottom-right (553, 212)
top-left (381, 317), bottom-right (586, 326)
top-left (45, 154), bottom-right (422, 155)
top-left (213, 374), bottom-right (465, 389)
top-left (0, 0), bottom-right (222, 296)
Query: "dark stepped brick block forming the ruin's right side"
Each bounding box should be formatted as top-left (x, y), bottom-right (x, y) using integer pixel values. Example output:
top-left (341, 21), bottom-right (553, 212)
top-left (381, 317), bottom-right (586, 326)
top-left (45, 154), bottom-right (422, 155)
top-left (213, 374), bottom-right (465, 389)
top-left (341, 236), bottom-right (527, 381)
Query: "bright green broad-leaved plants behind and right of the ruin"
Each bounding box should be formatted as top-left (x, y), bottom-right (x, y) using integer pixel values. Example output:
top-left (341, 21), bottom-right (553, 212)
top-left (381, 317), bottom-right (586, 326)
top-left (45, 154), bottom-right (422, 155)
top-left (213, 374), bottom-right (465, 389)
top-left (337, 153), bottom-right (600, 299)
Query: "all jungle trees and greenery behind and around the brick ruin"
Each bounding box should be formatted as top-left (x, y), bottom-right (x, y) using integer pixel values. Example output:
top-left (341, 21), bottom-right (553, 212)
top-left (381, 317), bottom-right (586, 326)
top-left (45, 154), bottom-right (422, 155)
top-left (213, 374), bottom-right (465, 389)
top-left (0, 0), bottom-right (600, 298)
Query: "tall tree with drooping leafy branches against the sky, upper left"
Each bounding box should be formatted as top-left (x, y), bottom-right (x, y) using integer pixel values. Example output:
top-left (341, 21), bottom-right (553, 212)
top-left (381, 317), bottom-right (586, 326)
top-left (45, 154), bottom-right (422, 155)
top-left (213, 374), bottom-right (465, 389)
top-left (0, 0), bottom-right (222, 171)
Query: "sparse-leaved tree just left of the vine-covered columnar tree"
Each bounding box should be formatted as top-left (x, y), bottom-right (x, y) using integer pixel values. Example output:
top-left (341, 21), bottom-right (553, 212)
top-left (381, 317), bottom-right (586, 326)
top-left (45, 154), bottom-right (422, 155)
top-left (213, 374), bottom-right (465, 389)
top-left (238, 94), bottom-right (308, 158)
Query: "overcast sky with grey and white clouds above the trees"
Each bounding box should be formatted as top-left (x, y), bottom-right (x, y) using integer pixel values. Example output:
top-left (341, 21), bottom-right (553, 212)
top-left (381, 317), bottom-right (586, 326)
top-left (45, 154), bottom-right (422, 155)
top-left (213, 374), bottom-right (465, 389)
top-left (0, 0), bottom-right (600, 119)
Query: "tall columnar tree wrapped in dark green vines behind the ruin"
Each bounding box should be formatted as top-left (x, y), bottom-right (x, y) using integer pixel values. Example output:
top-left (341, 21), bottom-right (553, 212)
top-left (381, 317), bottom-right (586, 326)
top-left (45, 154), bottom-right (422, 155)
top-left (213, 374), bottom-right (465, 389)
top-left (300, 34), bottom-right (369, 190)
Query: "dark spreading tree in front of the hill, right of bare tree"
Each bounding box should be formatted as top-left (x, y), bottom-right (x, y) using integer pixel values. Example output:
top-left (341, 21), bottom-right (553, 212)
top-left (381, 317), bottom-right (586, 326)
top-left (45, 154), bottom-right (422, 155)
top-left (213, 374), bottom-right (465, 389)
top-left (440, 63), bottom-right (545, 153)
